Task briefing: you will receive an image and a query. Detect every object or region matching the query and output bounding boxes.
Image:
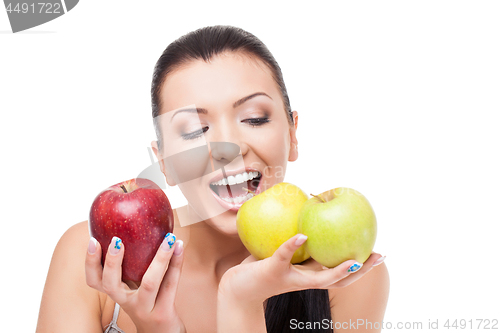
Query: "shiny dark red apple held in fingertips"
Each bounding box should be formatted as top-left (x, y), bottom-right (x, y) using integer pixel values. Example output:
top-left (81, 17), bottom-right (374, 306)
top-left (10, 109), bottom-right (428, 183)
top-left (89, 178), bottom-right (174, 282)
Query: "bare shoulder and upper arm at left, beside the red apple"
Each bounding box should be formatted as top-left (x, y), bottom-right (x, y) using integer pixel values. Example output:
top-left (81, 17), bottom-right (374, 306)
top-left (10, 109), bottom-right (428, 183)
top-left (36, 222), bottom-right (102, 333)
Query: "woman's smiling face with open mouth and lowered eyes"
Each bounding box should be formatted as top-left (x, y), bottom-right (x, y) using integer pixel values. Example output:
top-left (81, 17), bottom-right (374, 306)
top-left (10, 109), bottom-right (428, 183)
top-left (153, 53), bottom-right (298, 235)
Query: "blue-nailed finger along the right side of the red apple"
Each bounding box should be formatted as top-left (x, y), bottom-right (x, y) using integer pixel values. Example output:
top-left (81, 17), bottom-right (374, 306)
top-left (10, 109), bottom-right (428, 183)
top-left (137, 233), bottom-right (176, 311)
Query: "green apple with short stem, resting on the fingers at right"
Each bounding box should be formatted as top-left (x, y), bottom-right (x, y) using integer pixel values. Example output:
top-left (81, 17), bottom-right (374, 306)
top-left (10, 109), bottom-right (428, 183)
top-left (299, 187), bottom-right (377, 267)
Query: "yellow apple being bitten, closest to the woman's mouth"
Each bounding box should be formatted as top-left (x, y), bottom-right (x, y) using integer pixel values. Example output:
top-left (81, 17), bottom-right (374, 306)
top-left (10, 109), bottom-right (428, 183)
top-left (236, 183), bottom-right (309, 264)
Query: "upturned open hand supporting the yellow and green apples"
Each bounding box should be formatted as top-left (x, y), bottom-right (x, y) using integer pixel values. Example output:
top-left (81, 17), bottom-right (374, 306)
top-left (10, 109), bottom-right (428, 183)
top-left (219, 234), bottom-right (381, 304)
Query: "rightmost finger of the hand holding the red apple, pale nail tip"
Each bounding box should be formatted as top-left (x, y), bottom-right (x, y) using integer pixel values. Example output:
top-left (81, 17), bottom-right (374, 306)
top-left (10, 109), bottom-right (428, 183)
top-left (155, 240), bottom-right (184, 313)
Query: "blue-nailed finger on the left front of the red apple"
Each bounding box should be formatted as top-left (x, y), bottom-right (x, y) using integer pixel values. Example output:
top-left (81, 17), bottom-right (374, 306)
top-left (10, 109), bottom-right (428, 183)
top-left (102, 237), bottom-right (126, 304)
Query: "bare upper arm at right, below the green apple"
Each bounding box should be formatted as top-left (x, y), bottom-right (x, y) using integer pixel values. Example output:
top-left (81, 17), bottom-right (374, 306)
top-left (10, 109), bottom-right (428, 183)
top-left (329, 263), bottom-right (389, 333)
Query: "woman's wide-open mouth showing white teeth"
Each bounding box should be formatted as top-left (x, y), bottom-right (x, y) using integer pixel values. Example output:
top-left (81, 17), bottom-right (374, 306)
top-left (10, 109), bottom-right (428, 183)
top-left (210, 171), bottom-right (262, 204)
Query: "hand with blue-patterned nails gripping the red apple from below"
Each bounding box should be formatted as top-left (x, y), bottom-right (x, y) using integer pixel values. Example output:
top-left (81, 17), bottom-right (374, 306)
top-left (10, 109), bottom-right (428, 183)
top-left (85, 233), bottom-right (186, 333)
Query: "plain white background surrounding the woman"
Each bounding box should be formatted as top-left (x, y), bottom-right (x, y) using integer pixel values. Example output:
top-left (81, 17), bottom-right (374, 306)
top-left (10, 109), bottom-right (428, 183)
top-left (0, 0), bottom-right (500, 332)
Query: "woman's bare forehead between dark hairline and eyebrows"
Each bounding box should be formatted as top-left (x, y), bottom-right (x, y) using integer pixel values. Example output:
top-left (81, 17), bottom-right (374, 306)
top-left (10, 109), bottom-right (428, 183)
top-left (160, 52), bottom-right (281, 113)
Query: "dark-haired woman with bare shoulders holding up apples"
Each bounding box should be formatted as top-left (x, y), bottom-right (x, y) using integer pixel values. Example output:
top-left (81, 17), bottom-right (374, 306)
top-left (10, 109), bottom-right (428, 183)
top-left (37, 26), bottom-right (389, 333)
